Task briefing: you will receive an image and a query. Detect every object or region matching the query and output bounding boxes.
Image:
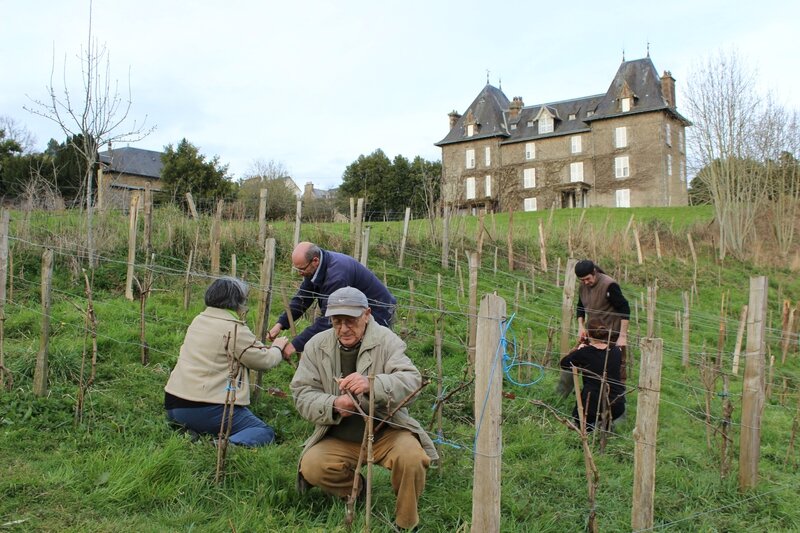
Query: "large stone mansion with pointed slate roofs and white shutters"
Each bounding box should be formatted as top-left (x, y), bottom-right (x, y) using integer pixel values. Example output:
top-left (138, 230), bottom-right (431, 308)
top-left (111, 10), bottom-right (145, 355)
top-left (436, 57), bottom-right (691, 212)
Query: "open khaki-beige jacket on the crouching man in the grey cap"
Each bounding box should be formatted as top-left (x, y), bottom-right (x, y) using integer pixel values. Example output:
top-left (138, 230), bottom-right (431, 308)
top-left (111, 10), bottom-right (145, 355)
top-left (291, 317), bottom-right (439, 490)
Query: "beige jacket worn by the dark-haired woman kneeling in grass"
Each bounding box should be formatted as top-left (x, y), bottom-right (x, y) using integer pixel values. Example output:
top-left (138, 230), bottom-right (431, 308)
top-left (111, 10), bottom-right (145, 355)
top-left (164, 307), bottom-right (282, 405)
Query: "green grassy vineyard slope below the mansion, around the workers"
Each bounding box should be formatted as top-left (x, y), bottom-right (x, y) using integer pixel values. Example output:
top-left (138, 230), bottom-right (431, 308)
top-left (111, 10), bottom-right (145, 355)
top-left (0, 203), bottom-right (800, 532)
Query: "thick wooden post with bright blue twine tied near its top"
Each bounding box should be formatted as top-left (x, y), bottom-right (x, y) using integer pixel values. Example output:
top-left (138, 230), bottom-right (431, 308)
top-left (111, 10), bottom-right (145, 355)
top-left (472, 294), bottom-right (506, 533)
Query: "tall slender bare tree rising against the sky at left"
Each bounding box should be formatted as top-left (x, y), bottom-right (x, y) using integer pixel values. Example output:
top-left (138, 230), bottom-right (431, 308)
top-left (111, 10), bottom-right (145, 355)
top-left (26, 1), bottom-right (152, 266)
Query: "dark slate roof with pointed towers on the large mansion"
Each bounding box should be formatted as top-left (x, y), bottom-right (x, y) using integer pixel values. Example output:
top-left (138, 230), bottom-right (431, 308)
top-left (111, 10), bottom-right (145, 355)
top-left (435, 57), bottom-right (691, 146)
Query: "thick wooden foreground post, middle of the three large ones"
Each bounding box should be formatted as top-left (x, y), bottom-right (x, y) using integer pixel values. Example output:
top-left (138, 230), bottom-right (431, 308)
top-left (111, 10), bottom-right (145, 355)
top-left (631, 339), bottom-right (663, 531)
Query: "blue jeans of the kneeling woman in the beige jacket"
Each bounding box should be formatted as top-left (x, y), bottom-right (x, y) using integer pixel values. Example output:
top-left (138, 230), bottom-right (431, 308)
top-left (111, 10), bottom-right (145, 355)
top-left (167, 405), bottom-right (275, 447)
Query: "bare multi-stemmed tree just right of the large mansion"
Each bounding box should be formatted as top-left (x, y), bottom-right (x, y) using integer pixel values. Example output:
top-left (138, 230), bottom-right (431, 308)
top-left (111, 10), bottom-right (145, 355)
top-left (686, 51), bottom-right (798, 259)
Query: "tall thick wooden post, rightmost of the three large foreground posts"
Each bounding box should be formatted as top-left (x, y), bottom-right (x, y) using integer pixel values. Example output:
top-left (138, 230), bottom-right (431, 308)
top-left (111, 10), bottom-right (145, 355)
top-left (739, 276), bottom-right (767, 490)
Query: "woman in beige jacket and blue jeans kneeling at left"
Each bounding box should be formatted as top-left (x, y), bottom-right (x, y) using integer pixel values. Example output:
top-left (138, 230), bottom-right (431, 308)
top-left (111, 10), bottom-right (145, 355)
top-left (164, 277), bottom-right (288, 447)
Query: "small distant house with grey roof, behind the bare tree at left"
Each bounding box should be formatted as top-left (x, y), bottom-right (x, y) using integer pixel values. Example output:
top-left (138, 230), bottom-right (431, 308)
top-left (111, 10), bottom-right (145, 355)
top-left (97, 146), bottom-right (164, 209)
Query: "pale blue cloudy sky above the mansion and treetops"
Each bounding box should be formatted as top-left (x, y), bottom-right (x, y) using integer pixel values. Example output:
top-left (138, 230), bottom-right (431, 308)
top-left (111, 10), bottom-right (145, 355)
top-left (0, 0), bottom-right (800, 189)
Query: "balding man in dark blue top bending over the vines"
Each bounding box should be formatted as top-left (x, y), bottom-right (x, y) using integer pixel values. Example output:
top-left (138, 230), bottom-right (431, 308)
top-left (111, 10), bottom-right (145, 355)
top-left (269, 242), bottom-right (397, 356)
